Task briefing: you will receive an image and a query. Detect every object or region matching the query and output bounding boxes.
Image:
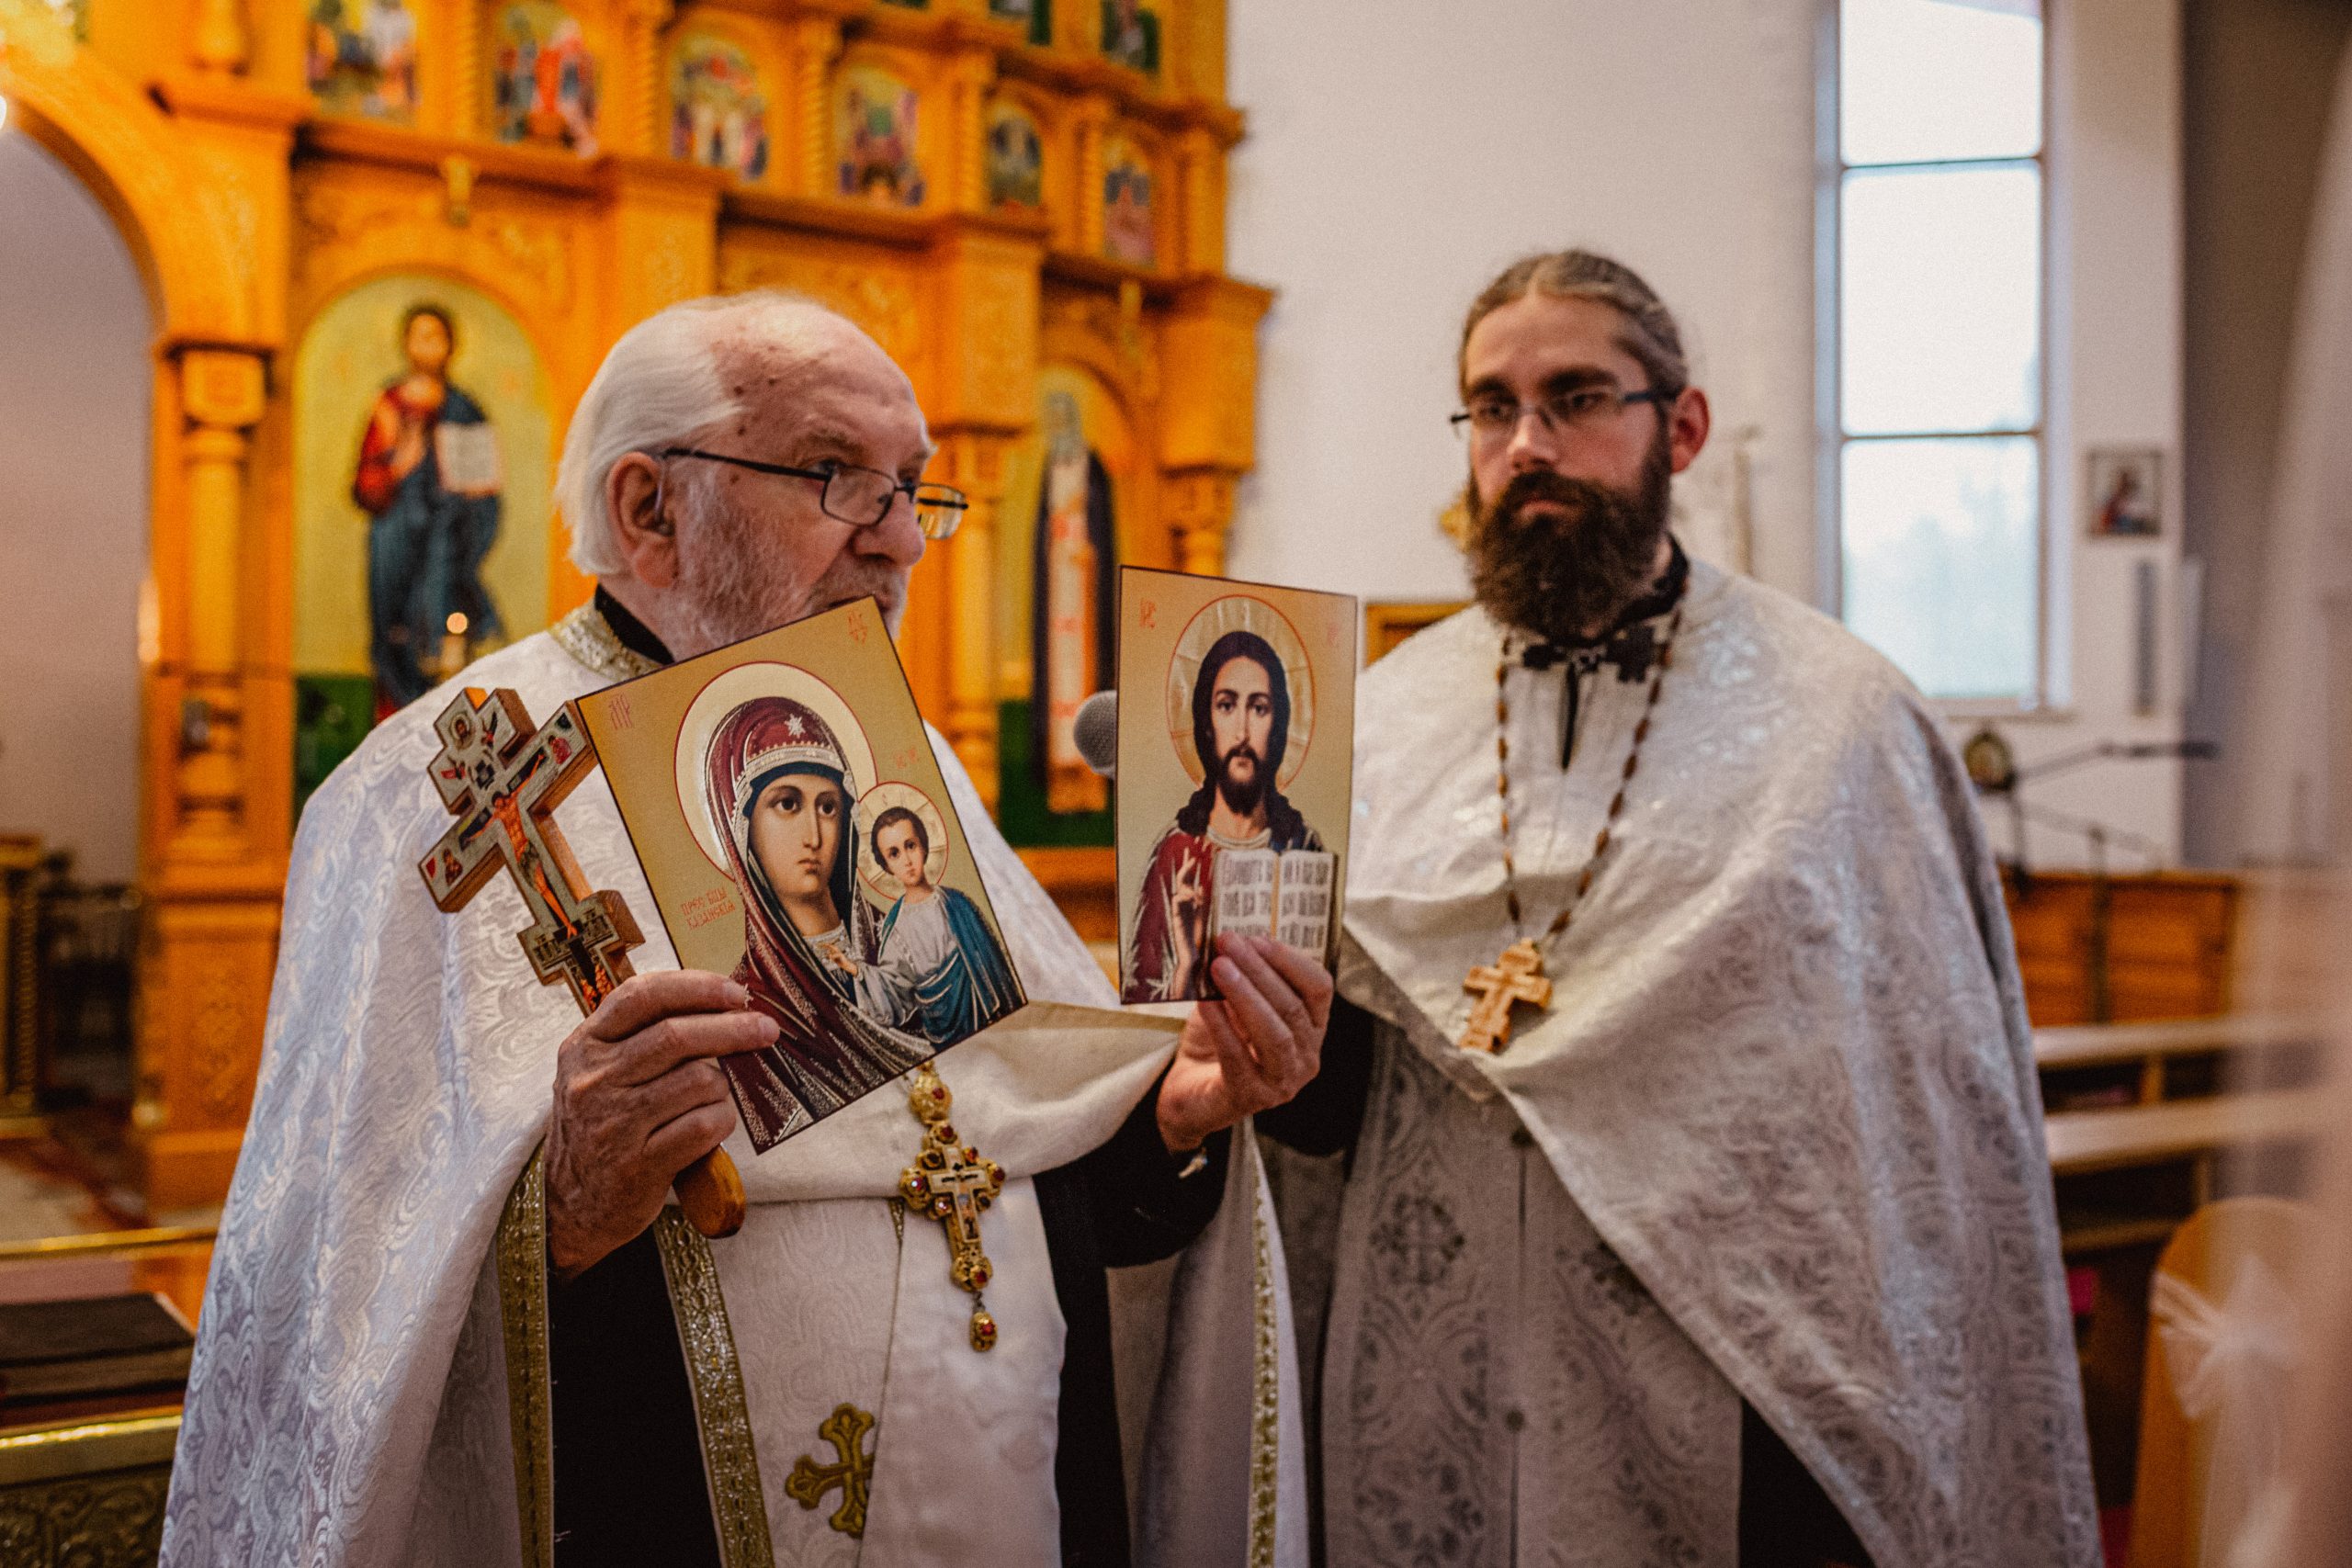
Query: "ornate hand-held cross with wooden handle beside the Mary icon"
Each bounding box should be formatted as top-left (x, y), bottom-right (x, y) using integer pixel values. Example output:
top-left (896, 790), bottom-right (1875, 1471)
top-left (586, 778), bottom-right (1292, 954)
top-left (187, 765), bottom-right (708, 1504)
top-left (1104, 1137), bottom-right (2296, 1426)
top-left (416, 686), bottom-right (743, 1236)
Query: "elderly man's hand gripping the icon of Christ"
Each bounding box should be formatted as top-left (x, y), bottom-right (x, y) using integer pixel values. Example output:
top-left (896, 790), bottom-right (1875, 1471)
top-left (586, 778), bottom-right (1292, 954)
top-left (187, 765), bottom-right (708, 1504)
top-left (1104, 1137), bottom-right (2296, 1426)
top-left (1159, 936), bottom-right (1331, 1155)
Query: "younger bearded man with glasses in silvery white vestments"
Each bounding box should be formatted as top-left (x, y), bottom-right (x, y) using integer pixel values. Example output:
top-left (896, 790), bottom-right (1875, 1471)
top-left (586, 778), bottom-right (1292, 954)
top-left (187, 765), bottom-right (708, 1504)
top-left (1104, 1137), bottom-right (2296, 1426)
top-left (1259, 252), bottom-right (2098, 1568)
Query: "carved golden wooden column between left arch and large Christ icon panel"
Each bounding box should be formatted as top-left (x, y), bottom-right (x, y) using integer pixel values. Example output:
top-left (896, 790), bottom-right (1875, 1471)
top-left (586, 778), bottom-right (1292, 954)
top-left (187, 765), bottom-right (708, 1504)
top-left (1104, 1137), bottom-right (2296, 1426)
top-left (119, 67), bottom-right (311, 1213)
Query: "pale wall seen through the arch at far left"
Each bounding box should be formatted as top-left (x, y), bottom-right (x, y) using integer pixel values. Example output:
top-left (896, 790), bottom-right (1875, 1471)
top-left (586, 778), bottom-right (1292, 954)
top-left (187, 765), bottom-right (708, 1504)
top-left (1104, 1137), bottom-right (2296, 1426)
top-left (0, 130), bottom-right (153, 879)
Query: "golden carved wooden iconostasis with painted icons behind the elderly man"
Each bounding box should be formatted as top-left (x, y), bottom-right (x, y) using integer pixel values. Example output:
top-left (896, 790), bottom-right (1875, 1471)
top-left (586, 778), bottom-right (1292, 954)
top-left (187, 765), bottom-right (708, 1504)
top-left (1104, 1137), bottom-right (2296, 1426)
top-left (0, 0), bottom-right (1268, 1211)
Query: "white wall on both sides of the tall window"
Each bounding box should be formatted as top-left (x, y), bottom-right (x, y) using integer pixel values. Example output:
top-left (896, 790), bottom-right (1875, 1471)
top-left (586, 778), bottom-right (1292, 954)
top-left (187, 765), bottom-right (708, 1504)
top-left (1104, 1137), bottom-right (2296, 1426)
top-left (1230, 0), bottom-right (2183, 865)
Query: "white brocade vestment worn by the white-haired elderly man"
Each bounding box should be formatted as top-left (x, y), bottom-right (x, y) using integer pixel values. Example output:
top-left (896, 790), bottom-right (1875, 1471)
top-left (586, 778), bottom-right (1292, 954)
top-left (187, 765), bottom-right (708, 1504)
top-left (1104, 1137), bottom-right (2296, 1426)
top-left (163, 635), bottom-right (1303, 1568)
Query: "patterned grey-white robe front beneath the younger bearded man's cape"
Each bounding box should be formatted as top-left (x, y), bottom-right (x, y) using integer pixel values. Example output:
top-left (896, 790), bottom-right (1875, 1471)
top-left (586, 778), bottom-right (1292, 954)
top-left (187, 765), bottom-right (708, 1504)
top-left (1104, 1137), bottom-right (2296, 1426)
top-left (1324, 1025), bottom-right (1740, 1568)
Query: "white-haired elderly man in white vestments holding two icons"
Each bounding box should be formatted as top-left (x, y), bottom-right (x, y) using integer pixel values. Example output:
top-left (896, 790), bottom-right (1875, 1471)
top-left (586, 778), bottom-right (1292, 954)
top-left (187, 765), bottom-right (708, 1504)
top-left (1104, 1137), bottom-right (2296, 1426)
top-left (163, 294), bottom-right (1331, 1568)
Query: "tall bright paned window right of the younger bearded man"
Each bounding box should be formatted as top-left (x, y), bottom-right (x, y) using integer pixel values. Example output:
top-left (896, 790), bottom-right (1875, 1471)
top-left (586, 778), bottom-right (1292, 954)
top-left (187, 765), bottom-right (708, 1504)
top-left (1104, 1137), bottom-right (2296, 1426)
top-left (1823, 0), bottom-right (2044, 703)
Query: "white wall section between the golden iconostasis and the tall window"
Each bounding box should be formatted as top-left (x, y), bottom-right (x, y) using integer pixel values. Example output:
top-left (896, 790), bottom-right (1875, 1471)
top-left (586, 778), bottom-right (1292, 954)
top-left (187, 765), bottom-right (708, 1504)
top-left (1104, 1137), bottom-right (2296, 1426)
top-left (1227, 0), bottom-right (1814, 600)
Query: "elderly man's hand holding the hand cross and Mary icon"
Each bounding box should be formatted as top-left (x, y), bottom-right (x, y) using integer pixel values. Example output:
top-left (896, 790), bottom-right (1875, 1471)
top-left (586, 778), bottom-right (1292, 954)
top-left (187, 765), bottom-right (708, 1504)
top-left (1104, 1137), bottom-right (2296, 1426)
top-left (546, 968), bottom-right (778, 1279)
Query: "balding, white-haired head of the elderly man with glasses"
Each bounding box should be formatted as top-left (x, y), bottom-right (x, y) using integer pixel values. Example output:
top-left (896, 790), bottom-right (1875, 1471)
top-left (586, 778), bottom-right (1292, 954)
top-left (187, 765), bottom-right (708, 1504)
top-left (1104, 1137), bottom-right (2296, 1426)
top-left (558, 291), bottom-right (932, 659)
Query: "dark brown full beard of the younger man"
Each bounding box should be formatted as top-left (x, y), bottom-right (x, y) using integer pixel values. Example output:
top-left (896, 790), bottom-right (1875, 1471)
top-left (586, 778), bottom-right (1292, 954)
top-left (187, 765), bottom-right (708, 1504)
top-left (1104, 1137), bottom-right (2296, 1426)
top-left (1463, 430), bottom-right (1675, 642)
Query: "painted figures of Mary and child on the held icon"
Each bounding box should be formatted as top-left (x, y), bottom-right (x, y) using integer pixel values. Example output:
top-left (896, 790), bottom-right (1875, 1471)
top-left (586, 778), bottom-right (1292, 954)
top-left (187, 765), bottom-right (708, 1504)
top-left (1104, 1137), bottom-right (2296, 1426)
top-left (703, 696), bottom-right (1021, 1149)
